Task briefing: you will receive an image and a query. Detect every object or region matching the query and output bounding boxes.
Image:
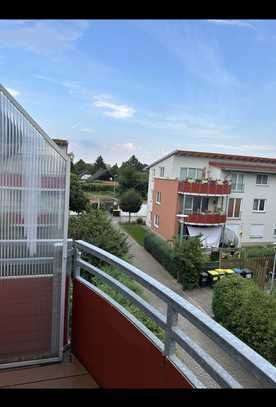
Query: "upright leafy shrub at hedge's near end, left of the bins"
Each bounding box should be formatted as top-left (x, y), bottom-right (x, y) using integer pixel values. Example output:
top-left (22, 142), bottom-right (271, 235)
top-left (174, 236), bottom-right (208, 290)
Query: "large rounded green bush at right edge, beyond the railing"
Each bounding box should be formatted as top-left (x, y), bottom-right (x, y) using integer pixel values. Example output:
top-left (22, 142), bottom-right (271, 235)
top-left (212, 275), bottom-right (276, 365)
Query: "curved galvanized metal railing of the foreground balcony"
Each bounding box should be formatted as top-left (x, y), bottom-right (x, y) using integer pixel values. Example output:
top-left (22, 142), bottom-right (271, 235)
top-left (71, 240), bottom-right (276, 388)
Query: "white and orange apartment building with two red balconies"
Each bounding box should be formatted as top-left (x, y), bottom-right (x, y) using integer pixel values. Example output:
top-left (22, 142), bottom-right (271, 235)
top-left (147, 150), bottom-right (276, 247)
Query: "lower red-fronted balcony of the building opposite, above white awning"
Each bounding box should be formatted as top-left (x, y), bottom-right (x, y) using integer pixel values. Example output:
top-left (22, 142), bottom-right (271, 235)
top-left (177, 195), bottom-right (227, 226)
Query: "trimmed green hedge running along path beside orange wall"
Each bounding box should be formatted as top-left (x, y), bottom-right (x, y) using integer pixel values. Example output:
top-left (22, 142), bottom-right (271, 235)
top-left (144, 233), bottom-right (177, 278)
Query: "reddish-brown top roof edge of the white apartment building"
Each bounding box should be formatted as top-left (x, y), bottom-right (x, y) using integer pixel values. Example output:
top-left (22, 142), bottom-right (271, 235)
top-left (145, 150), bottom-right (276, 169)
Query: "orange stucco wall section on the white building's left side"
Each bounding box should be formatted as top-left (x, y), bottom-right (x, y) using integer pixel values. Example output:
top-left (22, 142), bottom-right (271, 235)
top-left (151, 178), bottom-right (179, 240)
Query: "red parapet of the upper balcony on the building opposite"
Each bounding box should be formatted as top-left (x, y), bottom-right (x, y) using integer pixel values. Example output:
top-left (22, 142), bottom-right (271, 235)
top-left (178, 181), bottom-right (231, 195)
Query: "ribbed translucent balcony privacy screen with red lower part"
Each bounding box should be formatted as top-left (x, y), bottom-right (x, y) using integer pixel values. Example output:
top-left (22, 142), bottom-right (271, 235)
top-left (0, 86), bottom-right (68, 363)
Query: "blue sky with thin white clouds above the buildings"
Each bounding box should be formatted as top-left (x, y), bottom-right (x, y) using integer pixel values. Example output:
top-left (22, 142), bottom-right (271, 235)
top-left (0, 20), bottom-right (276, 164)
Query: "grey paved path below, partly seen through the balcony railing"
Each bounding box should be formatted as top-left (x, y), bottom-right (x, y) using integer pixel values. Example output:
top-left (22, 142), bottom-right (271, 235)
top-left (112, 218), bottom-right (262, 388)
